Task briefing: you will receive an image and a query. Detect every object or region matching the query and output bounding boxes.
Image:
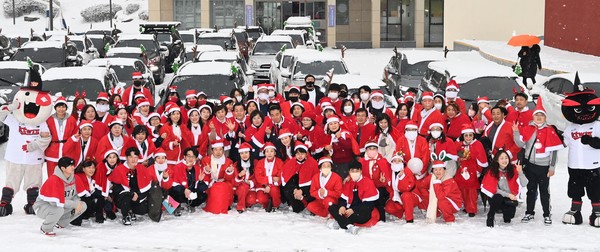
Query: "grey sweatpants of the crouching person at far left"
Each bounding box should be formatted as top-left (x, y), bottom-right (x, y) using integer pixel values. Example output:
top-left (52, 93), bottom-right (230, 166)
top-left (33, 200), bottom-right (87, 232)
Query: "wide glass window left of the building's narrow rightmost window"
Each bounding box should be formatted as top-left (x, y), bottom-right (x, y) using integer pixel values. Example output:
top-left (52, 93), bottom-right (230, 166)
top-left (381, 0), bottom-right (415, 41)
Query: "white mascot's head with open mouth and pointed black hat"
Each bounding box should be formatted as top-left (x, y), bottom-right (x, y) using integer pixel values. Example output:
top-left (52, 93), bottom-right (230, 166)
top-left (12, 68), bottom-right (52, 125)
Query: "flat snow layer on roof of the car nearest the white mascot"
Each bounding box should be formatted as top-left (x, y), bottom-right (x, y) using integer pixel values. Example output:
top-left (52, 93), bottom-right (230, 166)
top-left (42, 66), bottom-right (106, 82)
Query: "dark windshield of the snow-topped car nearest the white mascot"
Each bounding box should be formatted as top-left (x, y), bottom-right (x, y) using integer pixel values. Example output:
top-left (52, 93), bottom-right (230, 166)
top-left (44, 79), bottom-right (106, 101)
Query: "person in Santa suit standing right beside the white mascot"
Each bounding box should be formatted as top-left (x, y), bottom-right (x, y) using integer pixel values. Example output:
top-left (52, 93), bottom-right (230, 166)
top-left (44, 96), bottom-right (77, 177)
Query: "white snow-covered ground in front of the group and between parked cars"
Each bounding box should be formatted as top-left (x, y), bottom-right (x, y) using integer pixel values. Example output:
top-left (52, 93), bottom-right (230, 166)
top-left (0, 49), bottom-right (600, 251)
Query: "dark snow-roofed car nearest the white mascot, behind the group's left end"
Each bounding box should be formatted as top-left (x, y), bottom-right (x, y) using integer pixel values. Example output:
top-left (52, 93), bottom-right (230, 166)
top-left (42, 66), bottom-right (119, 102)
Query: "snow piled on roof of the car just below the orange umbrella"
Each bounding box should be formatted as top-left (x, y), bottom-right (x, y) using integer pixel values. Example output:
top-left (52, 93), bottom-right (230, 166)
top-left (428, 51), bottom-right (517, 84)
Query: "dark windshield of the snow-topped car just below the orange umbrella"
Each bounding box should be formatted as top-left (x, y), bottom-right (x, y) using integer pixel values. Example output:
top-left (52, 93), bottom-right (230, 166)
top-left (460, 77), bottom-right (520, 101)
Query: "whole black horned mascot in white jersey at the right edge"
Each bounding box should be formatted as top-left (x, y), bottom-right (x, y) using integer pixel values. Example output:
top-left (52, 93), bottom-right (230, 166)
top-left (561, 74), bottom-right (600, 227)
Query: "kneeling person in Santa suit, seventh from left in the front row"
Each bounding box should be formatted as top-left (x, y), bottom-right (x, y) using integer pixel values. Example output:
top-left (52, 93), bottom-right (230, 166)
top-left (233, 143), bottom-right (258, 213)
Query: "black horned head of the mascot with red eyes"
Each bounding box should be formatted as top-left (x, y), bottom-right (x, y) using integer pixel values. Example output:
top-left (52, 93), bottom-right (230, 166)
top-left (561, 73), bottom-right (600, 124)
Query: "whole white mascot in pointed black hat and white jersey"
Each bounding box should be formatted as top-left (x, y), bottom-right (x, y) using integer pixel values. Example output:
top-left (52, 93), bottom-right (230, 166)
top-left (0, 68), bottom-right (52, 216)
